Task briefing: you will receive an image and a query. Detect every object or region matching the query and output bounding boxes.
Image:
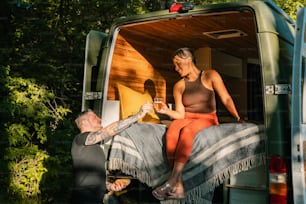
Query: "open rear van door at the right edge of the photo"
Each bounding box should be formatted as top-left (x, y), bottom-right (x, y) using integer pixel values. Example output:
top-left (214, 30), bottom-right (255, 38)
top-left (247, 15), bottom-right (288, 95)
top-left (291, 8), bottom-right (306, 204)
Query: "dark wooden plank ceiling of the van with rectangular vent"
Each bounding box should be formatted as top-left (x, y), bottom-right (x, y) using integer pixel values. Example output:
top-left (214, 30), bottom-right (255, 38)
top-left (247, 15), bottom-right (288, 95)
top-left (119, 11), bottom-right (258, 63)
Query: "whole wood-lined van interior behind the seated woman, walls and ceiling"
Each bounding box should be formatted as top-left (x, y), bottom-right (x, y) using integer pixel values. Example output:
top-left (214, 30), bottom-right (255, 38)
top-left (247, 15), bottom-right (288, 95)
top-left (103, 8), bottom-right (263, 123)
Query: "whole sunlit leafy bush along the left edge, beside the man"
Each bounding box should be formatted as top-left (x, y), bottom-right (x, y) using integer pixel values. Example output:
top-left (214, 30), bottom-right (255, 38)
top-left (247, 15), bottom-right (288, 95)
top-left (0, 67), bottom-right (74, 203)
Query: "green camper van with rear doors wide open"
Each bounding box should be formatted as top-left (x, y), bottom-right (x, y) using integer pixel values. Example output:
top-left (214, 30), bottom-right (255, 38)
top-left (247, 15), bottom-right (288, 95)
top-left (82, 0), bottom-right (306, 204)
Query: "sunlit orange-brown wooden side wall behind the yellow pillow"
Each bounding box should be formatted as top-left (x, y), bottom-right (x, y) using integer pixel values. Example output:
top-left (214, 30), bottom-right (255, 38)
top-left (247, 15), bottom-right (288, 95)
top-left (107, 35), bottom-right (166, 103)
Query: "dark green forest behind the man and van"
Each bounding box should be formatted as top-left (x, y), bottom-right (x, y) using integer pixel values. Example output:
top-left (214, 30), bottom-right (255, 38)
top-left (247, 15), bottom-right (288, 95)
top-left (0, 0), bottom-right (305, 203)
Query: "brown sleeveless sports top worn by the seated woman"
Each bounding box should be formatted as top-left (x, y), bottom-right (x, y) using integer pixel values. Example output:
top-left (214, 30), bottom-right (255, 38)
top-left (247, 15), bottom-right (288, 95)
top-left (182, 71), bottom-right (216, 113)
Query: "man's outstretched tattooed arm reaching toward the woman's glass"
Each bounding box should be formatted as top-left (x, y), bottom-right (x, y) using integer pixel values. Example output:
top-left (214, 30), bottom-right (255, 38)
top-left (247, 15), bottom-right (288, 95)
top-left (85, 103), bottom-right (153, 145)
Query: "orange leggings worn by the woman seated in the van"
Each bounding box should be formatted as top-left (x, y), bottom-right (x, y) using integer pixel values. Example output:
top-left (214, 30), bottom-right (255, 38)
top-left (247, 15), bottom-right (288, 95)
top-left (166, 112), bottom-right (219, 168)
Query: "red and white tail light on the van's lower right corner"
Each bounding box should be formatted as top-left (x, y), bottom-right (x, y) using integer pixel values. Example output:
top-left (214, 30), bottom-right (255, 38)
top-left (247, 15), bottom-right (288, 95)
top-left (269, 156), bottom-right (287, 204)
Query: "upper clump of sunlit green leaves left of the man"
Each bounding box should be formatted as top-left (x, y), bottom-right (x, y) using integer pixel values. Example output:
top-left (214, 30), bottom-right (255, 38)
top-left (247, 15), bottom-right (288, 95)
top-left (5, 71), bottom-right (69, 145)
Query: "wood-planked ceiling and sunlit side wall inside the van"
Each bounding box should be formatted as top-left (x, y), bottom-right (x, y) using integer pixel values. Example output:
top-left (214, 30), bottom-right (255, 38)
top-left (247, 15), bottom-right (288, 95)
top-left (107, 10), bottom-right (259, 121)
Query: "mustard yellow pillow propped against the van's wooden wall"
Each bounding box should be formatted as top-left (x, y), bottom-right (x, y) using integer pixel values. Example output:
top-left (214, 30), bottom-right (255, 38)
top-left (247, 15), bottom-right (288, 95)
top-left (117, 83), bottom-right (160, 123)
